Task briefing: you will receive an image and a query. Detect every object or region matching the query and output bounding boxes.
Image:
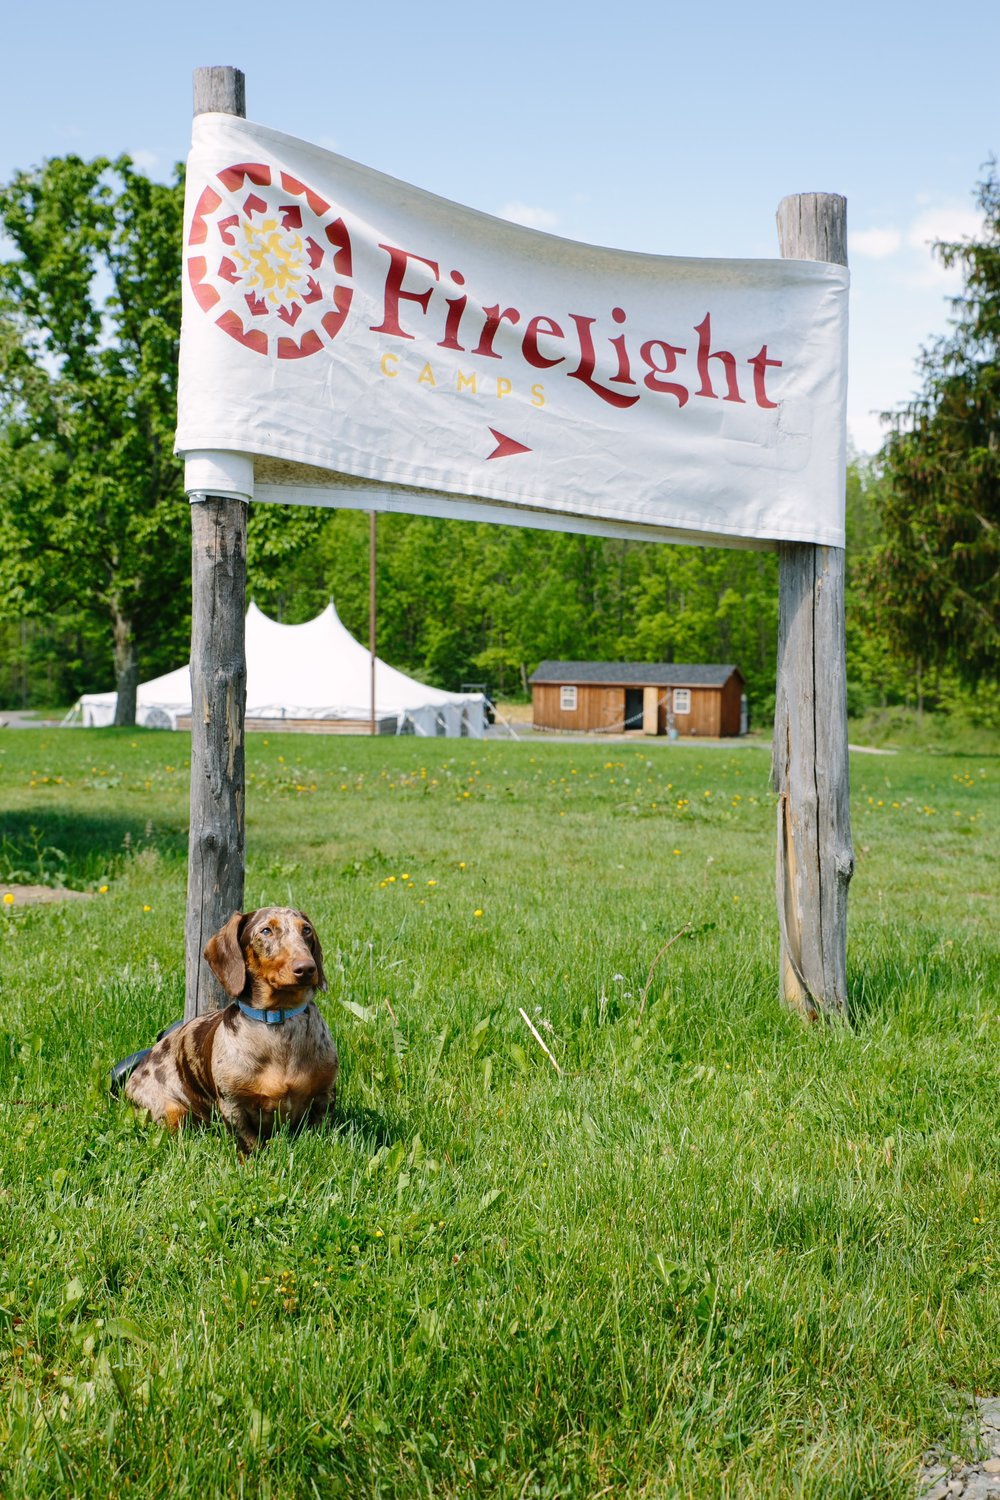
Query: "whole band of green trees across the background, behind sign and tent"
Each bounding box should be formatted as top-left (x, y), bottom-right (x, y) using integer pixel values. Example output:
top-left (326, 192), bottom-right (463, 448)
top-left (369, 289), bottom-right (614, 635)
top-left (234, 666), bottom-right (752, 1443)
top-left (0, 156), bottom-right (1000, 723)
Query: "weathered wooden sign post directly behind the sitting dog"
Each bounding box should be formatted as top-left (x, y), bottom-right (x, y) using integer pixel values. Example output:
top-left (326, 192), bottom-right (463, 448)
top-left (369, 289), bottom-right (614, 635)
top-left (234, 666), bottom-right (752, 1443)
top-left (184, 68), bottom-right (247, 1020)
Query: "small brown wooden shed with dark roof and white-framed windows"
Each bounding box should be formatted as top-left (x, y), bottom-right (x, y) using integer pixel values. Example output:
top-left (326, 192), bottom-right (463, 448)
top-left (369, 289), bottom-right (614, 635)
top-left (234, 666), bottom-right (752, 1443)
top-left (528, 662), bottom-right (747, 738)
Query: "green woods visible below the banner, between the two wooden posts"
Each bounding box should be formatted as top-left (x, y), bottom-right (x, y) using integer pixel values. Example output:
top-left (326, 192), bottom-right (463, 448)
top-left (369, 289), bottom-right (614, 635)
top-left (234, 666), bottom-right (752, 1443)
top-left (293, 507), bottom-right (778, 716)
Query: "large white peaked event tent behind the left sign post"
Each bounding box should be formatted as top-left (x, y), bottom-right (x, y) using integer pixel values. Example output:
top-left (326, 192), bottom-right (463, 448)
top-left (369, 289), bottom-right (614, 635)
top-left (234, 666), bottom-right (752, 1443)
top-left (73, 603), bottom-right (486, 738)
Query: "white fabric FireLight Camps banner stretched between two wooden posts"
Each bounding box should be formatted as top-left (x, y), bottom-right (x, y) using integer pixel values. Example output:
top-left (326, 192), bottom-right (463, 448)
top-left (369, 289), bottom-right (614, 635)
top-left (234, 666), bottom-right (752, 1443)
top-left (177, 114), bottom-right (849, 546)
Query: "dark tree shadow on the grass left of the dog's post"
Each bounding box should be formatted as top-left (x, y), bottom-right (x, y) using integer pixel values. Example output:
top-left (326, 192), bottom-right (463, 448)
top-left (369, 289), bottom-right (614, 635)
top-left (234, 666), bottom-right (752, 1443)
top-left (0, 809), bottom-right (187, 890)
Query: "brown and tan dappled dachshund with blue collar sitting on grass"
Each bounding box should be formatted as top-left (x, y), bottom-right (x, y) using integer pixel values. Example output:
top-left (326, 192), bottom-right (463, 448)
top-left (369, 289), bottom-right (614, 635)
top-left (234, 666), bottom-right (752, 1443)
top-left (124, 906), bottom-right (337, 1151)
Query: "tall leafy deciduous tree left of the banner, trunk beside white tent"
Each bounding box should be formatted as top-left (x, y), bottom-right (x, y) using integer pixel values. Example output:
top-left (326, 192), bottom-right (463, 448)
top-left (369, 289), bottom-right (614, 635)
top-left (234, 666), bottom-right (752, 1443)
top-left (0, 156), bottom-right (190, 723)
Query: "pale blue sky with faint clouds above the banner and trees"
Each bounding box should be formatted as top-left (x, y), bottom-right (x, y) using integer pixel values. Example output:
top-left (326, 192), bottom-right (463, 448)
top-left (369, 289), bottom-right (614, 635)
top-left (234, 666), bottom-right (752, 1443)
top-left (0, 0), bottom-right (1000, 452)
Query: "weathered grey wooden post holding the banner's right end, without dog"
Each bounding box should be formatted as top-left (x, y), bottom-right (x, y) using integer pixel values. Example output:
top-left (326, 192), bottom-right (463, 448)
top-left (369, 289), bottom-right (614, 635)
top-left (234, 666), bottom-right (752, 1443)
top-left (772, 194), bottom-right (855, 1020)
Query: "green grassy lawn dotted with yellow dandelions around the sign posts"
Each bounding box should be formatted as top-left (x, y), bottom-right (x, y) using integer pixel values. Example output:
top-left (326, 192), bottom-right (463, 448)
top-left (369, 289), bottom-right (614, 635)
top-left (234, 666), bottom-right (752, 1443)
top-left (0, 731), bottom-right (1000, 1500)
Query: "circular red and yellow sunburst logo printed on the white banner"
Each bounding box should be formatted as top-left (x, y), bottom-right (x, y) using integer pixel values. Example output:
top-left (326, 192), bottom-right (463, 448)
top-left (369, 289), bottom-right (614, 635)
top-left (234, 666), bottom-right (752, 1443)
top-left (187, 162), bottom-right (352, 360)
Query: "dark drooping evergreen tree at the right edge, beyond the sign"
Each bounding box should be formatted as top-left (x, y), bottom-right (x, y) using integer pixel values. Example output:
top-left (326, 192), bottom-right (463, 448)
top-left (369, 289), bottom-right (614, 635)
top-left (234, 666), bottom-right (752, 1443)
top-left (868, 162), bottom-right (1000, 693)
